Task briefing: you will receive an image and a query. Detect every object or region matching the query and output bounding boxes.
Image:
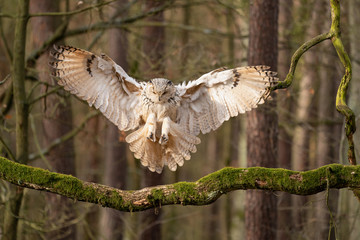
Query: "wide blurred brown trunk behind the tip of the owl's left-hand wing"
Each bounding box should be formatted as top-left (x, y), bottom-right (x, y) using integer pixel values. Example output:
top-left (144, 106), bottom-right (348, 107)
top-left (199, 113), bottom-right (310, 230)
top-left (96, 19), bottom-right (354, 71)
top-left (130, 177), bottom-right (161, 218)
top-left (30, 0), bottom-right (76, 239)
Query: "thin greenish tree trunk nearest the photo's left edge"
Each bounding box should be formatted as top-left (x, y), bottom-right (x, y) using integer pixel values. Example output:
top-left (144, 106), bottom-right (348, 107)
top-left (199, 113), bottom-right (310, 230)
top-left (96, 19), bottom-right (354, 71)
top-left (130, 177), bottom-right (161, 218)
top-left (3, 0), bottom-right (29, 240)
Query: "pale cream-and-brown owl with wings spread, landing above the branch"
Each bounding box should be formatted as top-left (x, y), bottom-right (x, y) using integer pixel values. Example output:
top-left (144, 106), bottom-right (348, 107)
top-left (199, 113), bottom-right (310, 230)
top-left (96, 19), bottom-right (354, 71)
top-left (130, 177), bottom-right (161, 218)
top-left (50, 46), bottom-right (278, 173)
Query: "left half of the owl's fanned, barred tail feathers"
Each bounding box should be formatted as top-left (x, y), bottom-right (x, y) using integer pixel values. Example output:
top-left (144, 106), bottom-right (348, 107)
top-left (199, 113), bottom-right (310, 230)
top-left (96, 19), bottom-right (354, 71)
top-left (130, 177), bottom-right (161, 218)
top-left (125, 125), bottom-right (164, 173)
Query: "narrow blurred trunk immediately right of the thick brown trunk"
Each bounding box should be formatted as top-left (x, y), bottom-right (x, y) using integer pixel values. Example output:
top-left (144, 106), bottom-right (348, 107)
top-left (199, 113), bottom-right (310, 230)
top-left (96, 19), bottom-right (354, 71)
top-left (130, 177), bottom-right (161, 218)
top-left (277, 0), bottom-right (293, 240)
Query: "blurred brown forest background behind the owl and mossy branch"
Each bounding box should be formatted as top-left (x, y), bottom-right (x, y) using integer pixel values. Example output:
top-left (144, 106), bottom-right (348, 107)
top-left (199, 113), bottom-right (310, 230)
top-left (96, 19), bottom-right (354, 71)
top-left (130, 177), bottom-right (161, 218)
top-left (0, 0), bottom-right (360, 240)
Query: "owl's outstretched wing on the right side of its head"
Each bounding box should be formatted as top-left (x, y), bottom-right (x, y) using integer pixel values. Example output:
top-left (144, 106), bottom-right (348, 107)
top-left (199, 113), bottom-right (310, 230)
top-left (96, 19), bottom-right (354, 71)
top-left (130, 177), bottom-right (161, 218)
top-left (177, 66), bottom-right (278, 135)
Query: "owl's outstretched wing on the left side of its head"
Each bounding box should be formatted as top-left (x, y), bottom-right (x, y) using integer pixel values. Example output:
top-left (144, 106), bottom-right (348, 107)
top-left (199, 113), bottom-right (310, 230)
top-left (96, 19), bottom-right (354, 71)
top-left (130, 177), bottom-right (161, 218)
top-left (50, 46), bottom-right (142, 131)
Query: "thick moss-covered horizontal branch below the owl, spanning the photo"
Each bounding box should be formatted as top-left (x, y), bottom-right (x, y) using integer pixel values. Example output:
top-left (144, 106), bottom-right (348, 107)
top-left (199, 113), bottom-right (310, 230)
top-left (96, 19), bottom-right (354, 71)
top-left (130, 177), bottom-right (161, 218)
top-left (0, 157), bottom-right (360, 212)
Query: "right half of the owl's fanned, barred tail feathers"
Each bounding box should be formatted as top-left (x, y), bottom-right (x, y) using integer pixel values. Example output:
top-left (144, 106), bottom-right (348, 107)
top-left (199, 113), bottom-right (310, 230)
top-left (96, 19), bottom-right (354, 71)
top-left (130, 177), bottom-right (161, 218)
top-left (162, 121), bottom-right (201, 171)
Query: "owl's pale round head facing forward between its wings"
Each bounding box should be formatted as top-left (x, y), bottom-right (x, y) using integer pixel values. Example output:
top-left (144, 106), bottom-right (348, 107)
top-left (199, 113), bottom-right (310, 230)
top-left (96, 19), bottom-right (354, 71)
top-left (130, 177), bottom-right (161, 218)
top-left (146, 78), bottom-right (176, 103)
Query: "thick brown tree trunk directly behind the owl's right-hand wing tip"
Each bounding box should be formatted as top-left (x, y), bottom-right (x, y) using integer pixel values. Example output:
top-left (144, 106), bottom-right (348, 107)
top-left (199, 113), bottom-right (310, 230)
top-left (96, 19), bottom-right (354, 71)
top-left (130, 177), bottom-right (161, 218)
top-left (245, 0), bottom-right (278, 240)
